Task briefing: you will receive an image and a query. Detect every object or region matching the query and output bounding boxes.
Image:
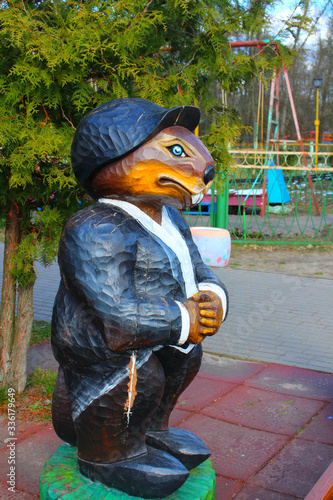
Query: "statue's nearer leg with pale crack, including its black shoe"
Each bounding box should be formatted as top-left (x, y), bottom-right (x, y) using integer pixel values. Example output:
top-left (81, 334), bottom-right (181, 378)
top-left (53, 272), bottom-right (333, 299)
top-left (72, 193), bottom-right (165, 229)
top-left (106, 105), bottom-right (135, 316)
top-left (75, 354), bottom-right (188, 498)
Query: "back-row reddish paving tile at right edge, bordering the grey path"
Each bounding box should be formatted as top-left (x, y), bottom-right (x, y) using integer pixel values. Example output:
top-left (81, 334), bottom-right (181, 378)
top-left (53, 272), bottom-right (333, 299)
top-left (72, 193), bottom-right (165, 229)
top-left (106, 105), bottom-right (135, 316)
top-left (245, 365), bottom-right (333, 401)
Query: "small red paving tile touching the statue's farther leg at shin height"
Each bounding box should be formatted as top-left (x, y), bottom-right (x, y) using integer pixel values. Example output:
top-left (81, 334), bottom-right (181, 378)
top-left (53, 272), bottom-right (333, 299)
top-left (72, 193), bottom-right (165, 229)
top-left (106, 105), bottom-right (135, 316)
top-left (176, 375), bottom-right (236, 410)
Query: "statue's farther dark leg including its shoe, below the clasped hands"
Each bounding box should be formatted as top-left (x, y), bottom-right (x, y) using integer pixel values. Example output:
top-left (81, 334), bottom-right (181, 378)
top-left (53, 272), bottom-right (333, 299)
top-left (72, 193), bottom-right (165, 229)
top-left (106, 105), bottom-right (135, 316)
top-left (146, 344), bottom-right (210, 470)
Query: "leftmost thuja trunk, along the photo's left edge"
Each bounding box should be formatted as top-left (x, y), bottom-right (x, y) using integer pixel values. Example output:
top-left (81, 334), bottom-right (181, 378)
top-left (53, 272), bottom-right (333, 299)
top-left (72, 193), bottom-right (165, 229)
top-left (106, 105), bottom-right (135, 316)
top-left (0, 203), bottom-right (20, 386)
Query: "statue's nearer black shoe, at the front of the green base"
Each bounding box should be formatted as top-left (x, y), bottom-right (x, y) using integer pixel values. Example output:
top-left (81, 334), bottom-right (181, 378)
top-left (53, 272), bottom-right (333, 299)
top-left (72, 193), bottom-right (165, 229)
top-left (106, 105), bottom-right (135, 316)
top-left (78, 446), bottom-right (189, 498)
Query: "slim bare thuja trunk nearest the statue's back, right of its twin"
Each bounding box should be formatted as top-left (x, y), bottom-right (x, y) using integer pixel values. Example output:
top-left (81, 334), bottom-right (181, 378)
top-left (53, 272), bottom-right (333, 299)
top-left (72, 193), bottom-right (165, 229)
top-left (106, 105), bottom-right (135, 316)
top-left (8, 280), bottom-right (35, 393)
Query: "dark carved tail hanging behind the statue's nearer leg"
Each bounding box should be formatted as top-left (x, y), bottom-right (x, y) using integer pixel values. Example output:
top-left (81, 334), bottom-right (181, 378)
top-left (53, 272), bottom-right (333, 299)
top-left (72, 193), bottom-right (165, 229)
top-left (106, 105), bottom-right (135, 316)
top-left (52, 366), bottom-right (76, 446)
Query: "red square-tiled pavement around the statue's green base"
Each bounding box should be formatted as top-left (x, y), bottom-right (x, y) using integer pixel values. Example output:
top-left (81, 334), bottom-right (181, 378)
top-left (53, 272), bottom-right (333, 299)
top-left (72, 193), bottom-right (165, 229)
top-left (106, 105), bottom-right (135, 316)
top-left (0, 360), bottom-right (333, 500)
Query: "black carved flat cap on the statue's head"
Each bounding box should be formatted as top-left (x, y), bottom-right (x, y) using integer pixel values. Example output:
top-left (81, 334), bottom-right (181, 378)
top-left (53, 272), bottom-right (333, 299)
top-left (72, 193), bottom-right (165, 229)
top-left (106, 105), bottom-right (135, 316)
top-left (71, 98), bottom-right (200, 192)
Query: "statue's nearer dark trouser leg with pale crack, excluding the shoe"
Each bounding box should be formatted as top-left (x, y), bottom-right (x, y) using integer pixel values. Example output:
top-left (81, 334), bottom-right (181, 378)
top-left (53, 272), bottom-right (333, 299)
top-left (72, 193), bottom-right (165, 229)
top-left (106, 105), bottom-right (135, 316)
top-left (75, 355), bottom-right (164, 462)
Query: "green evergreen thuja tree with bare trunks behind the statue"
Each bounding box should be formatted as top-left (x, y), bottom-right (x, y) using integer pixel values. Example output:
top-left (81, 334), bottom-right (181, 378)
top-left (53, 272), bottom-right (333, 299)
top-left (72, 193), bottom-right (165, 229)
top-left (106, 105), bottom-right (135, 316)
top-left (0, 0), bottom-right (284, 391)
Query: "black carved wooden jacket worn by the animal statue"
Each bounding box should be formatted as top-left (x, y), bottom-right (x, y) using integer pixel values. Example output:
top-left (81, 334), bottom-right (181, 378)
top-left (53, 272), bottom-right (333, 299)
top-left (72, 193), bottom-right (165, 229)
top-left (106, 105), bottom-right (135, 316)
top-left (52, 203), bottom-right (226, 417)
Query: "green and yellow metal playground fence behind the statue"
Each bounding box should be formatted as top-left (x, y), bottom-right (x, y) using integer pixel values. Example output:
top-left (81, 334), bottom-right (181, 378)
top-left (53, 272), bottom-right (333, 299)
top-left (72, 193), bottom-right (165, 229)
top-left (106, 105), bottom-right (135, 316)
top-left (185, 149), bottom-right (333, 245)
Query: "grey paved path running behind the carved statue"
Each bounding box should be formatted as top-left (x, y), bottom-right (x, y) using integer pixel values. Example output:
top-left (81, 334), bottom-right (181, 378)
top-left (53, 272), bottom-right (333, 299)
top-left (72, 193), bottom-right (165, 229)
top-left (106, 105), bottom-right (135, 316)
top-left (0, 243), bottom-right (333, 372)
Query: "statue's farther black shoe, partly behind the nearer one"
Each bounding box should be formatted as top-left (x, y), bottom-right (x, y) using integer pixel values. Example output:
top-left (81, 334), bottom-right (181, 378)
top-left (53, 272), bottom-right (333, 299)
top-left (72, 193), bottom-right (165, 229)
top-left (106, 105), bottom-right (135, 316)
top-left (146, 427), bottom-right (210, 470)
